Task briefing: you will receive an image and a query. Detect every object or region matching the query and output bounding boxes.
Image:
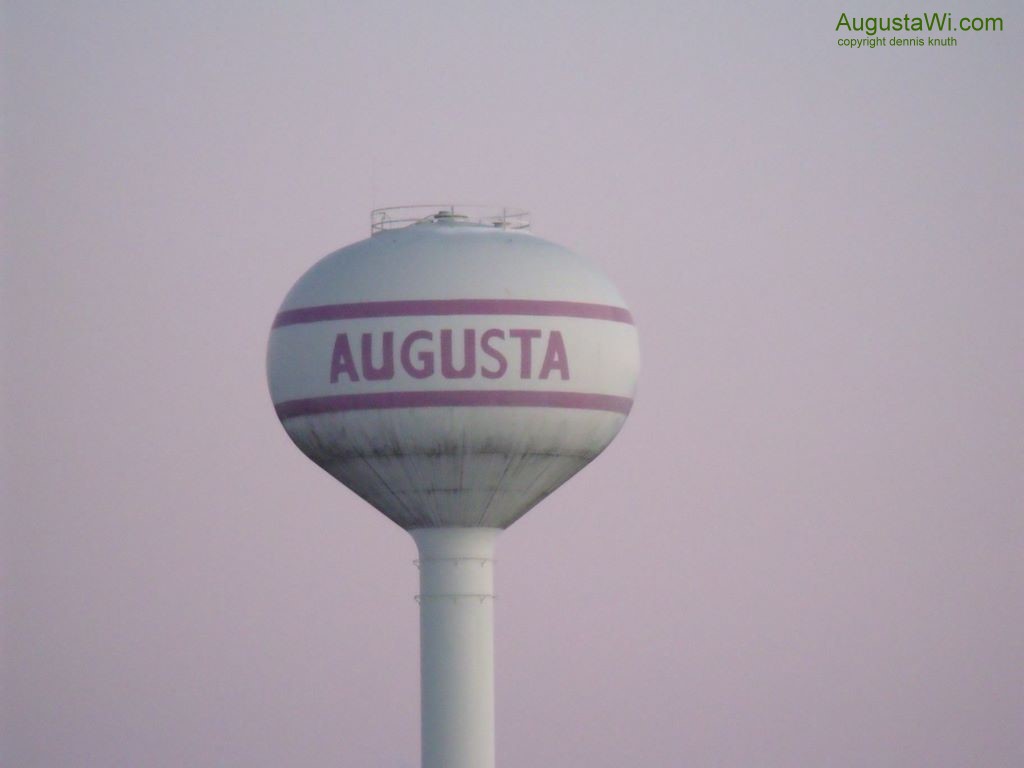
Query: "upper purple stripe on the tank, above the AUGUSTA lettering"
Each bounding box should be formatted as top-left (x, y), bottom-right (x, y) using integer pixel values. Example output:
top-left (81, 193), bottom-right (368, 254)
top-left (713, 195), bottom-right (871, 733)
top-left (273, 299), bottom-right (633, 328)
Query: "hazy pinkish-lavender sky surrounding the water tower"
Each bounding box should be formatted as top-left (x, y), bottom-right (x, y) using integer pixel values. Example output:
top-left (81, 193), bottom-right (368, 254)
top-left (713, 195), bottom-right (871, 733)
top-left (0, 0), bottom-right (1024, 768)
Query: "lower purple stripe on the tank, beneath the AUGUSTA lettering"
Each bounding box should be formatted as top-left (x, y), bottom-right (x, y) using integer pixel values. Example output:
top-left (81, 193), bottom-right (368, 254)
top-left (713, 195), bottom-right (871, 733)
top-left (274, 389), bottom-right (633, 420)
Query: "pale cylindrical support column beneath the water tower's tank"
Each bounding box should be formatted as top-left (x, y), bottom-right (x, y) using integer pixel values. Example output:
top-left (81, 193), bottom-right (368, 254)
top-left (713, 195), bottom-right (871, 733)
top-left (410, 527), bottom-right (501, 768)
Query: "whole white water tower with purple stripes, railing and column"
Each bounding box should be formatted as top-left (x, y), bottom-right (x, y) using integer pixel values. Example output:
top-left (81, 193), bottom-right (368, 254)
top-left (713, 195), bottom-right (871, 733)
top-left (267, 206), bottom-right (638, 768)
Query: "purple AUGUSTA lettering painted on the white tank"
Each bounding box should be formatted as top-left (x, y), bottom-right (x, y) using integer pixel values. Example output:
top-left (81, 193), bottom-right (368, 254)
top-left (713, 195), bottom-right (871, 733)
top-left (331, 328), bottom-right (569, 384)
